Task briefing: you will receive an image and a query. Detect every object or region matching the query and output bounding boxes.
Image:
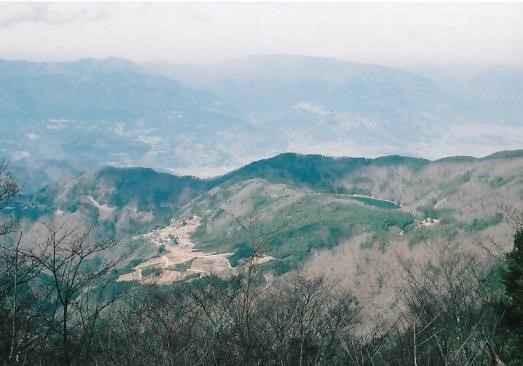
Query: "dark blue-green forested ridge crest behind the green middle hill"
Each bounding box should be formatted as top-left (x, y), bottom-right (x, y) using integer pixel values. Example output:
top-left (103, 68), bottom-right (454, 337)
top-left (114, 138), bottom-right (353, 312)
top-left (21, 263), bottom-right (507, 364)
top-left (16, 150), bottom-right (523, 213)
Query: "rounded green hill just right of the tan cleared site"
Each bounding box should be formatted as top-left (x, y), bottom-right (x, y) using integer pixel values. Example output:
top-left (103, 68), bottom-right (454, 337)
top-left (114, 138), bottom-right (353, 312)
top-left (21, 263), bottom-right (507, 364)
top-left (178, 179), bottom-right (414, 270)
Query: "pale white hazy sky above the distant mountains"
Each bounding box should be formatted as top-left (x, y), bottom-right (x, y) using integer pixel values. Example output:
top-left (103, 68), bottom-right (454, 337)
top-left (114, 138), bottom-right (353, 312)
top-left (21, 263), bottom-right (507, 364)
top-left (0, 3), bottom-right (523, 66)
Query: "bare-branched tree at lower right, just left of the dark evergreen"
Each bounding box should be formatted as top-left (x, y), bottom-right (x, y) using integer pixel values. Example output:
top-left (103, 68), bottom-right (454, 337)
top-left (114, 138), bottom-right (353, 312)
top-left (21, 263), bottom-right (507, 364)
top-left (401, 244), bottom-right (508, 365)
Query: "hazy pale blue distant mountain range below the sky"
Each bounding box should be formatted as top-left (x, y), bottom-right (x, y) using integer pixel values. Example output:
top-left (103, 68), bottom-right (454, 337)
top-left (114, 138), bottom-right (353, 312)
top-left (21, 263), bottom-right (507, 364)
top-left (0, 55), bottom-right (523, 192)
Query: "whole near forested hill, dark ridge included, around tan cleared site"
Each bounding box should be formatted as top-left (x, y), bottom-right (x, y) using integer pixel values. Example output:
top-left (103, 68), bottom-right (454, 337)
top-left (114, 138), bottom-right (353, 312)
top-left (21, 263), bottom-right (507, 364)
top-left (0, 151), bottom-right (523, 365)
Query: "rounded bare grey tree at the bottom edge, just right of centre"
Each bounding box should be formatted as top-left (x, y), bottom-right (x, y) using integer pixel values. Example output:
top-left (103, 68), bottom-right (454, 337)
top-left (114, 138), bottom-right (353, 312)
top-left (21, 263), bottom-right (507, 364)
top-left (256, 271), bottom-right (359, 365)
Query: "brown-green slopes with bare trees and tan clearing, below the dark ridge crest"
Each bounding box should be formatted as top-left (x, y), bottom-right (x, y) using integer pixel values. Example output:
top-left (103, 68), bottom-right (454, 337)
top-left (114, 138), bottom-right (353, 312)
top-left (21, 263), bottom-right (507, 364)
top-left (4, 152), bottom-right (523, 365)
